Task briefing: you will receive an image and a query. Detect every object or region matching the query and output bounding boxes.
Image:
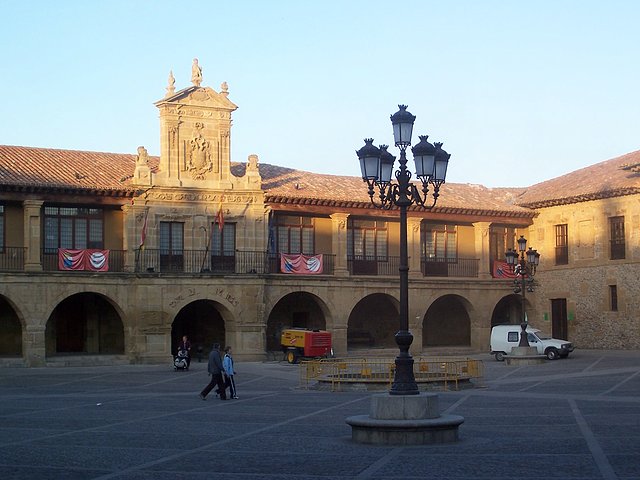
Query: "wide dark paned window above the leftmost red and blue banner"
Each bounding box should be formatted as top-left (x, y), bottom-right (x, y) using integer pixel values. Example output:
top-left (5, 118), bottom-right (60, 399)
top-left (44, 206), bottom-right (104, 253)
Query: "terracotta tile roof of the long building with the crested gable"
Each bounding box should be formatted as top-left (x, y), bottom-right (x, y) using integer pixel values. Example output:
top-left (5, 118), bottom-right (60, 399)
top-left (0, 146), bottom-right (531, 216)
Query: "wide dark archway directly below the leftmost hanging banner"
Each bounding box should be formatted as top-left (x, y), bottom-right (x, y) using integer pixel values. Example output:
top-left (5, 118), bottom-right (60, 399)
top-left (45, 293), bottom-right (124, 355)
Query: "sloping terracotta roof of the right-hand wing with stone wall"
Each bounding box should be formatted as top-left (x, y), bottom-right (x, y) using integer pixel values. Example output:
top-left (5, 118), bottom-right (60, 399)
top-left (516, 150), bottom-right (640, 208)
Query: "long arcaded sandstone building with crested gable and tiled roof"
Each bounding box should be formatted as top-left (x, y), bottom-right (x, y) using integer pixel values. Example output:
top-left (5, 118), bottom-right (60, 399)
top-left (0, 65), bottom-right (640, 366)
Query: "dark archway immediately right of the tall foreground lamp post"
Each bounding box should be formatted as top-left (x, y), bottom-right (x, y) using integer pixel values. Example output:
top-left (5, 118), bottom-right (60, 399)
top-left (422, 295), bottom-right (471, 347)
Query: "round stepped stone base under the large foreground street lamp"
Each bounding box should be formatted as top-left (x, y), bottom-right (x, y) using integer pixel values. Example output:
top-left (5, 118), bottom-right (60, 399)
top-left (346, 393), bottom-right (464, 445)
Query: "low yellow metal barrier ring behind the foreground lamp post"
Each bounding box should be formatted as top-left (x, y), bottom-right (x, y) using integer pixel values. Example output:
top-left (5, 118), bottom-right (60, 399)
top-left (300, 357), bottom-right (484, 392)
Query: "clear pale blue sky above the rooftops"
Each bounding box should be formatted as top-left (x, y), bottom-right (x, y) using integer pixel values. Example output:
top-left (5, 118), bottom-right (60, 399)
top-left (0, 0), bottom-right (640, 187)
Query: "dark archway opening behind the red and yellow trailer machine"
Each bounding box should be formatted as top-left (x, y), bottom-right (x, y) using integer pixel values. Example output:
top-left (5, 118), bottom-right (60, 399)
top-left (267, 292), bottom-right (328, 352)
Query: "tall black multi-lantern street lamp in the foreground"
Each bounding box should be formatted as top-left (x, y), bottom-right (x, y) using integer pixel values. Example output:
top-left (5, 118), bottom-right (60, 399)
top-left (356, 105), bottom-right (451, 395)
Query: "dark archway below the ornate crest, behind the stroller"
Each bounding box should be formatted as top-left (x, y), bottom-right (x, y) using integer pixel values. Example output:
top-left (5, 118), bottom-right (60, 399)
top-left (171, 300), bottom-right (226, 361)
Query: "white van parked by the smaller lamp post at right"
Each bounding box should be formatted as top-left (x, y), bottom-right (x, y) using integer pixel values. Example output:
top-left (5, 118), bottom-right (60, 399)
top-left (491, 325), bottom-right (573, 362)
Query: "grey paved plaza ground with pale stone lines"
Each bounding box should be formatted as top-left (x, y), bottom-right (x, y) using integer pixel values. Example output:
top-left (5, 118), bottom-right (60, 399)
top-left (0, 350), bottom-right (640, 480)
